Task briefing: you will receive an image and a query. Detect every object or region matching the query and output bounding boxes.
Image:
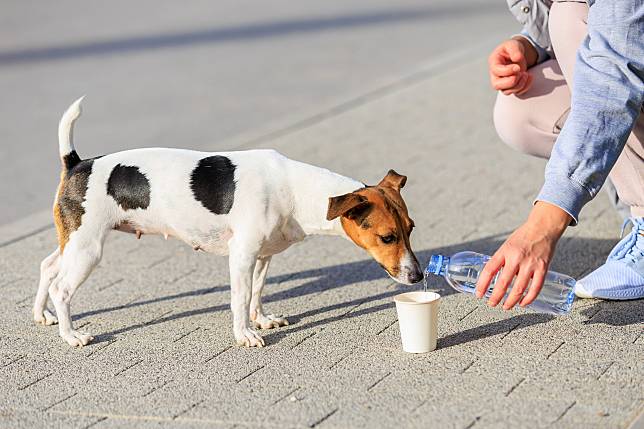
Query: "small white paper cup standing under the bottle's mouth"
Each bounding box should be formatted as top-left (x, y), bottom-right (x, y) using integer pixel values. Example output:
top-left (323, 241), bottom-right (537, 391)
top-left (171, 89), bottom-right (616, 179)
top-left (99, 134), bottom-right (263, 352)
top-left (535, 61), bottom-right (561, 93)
top-left (394, 292), bottom-right (441, 353)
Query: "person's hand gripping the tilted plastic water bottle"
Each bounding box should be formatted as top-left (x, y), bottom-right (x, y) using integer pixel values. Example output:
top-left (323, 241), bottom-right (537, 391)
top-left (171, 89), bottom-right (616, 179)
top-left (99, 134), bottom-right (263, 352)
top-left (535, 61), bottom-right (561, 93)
top-left (476, 201), bottom-right (572, 310)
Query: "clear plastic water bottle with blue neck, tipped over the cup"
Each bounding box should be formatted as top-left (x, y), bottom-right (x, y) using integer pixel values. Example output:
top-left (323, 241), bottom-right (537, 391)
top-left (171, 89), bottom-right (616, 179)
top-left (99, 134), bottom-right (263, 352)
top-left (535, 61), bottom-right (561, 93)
top-left (425, 252), bottom-right (575, 315)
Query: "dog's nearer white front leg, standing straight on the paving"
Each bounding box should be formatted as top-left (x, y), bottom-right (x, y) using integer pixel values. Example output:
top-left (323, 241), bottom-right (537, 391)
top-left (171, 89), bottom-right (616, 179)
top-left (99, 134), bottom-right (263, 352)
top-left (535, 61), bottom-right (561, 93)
top-left (228, 243), bottom-right (264, 347)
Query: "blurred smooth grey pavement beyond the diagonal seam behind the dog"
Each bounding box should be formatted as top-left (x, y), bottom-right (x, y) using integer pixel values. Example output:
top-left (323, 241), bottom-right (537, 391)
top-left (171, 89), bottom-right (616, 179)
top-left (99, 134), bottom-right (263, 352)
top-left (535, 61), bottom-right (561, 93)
top-left (0, 0), bottom-right (518, 225)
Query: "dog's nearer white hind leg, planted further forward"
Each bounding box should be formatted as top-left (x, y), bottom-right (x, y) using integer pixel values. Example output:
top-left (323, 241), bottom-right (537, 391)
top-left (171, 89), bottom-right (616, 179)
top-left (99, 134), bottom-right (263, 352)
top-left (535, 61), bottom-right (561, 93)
top-left (49, 230), bottom-right (103, 347)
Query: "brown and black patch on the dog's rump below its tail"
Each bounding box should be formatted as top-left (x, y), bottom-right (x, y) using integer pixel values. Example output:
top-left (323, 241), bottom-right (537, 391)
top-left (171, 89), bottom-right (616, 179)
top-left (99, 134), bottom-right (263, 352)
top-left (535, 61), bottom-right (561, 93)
top-left (57, 155), bottom-right (94, 237)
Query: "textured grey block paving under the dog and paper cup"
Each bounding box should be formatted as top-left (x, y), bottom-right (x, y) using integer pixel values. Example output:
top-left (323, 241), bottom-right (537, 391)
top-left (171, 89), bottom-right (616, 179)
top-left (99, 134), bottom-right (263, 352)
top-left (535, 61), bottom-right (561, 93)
top-left (0, 41), bottom-right (644, 428)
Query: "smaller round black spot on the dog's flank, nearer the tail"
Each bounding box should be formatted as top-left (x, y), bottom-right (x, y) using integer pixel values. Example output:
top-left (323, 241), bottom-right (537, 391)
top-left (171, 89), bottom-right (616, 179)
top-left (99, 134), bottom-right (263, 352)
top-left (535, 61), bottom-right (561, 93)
top-left (107, 164), bottom-right (150, 210)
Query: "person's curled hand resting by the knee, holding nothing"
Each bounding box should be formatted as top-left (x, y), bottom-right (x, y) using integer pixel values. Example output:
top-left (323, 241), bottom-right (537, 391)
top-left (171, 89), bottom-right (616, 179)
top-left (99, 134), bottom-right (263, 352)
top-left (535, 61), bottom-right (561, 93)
top-left (488, 37), bottom-right (537, 95)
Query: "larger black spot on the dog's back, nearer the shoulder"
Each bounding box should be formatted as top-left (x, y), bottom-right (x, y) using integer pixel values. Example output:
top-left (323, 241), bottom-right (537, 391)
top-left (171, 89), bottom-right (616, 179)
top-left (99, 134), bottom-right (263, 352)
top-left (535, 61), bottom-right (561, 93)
top-left (190, 155), bottom-right (235, 214)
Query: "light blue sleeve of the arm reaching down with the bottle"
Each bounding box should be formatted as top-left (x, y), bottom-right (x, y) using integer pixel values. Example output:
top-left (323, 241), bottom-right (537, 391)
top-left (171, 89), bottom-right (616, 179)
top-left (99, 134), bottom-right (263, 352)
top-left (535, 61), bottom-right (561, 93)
top-left (536, 0), bottom-right (644, 225)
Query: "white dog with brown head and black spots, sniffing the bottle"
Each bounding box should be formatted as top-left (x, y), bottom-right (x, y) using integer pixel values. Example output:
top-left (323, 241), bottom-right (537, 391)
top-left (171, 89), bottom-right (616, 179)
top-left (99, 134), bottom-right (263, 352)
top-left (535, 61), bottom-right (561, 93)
top-left (33, 97), bottom-right (423, 347)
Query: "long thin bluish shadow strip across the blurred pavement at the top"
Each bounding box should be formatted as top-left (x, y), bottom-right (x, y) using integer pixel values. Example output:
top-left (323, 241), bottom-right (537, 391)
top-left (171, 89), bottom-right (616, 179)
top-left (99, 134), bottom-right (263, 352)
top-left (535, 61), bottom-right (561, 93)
top-left (0, 2), bottom-right (503, 66)
